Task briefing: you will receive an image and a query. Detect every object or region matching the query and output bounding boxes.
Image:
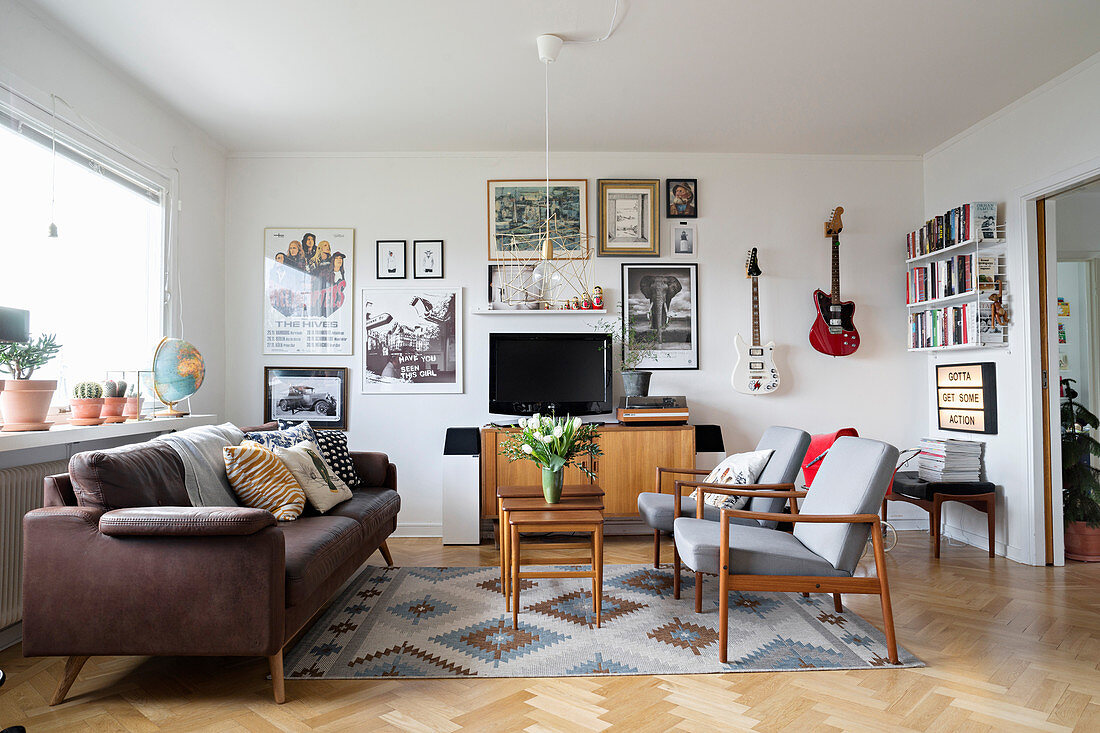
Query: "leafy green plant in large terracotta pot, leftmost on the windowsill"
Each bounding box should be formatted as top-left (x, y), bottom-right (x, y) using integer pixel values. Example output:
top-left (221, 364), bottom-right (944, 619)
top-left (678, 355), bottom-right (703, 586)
top-left (0, 333), bottom-right (61, 433)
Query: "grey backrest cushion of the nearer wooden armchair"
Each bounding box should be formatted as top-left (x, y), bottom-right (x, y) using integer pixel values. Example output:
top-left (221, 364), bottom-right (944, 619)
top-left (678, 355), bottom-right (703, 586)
top-left (794, 437), bottom-right (898, 573)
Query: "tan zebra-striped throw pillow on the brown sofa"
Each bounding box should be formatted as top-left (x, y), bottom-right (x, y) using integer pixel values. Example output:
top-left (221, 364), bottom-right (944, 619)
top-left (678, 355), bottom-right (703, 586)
top-left (221, 440), bottom-right (306, 522)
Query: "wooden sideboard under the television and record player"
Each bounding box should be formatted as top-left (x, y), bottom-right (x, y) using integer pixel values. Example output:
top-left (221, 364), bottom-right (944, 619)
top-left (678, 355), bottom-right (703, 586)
top-left (481, 425), bottom-right (695, 517)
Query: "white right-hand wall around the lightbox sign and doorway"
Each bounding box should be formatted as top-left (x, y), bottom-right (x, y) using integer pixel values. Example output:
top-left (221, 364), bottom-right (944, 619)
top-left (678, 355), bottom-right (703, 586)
top-left (923, 55), bottom-right (1100, 565)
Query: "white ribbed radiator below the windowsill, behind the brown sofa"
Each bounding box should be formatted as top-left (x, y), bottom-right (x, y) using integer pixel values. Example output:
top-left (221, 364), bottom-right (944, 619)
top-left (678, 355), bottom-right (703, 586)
top-left (0, 461), bottom-right (68, 628)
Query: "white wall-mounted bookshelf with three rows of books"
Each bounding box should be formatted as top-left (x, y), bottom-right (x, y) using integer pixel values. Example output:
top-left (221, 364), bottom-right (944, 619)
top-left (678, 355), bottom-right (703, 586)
top-left (905, 201), bottom-right (1009, 351)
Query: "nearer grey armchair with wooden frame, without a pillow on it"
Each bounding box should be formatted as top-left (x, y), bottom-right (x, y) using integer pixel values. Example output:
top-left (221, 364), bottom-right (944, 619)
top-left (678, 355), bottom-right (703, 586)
top-left (673, 437), bottom-right (898, 664)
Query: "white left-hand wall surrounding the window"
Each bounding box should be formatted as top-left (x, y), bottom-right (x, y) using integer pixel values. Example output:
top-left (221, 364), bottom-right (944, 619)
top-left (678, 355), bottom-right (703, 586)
top-left (0, 0), bottom-right (226, 414)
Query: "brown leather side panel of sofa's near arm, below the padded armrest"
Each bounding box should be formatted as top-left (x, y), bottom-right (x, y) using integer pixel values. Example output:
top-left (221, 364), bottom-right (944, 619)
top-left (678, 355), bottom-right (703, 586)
top-left (23, 506), bottom-right (286, 656)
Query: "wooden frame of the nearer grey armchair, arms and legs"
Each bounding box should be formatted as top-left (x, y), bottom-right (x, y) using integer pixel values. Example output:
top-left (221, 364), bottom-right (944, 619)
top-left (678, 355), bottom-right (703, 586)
top-left (717, 506), bottom-right (898, 665)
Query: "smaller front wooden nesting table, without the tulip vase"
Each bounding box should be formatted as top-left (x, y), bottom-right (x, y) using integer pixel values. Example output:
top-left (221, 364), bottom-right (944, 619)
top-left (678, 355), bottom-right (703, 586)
top-left (508, 510), bottom-right (604, 630)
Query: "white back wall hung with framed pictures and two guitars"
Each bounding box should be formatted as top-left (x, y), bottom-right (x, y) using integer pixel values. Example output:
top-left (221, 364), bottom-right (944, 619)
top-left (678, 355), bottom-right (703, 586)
top-left (226, 153), bottom-right (927, 535)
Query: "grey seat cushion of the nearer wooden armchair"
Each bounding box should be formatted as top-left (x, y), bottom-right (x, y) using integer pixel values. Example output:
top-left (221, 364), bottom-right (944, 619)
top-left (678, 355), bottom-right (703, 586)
top-left (673, 517), bottom-right (851, 577)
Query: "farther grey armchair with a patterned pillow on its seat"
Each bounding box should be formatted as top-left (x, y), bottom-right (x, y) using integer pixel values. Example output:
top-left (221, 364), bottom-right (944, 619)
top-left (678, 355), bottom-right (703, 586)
top-left (638, 426), bottom-right (810, 572)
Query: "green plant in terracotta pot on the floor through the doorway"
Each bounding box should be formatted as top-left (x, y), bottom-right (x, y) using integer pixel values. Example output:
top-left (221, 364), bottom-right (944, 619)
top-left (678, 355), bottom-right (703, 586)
top-left (1062, 379), bottom-right (1100, 562)
